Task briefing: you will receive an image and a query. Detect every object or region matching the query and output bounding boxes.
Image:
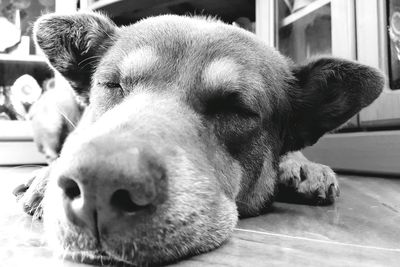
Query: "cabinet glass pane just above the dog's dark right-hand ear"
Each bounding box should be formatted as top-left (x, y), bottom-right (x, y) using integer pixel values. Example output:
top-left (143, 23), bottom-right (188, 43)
top-left (277, 1), bottom-right (332, 62)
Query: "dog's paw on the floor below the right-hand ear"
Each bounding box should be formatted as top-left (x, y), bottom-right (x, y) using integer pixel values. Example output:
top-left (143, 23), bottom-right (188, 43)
top-left (278, 151), bottom-right (339, 205)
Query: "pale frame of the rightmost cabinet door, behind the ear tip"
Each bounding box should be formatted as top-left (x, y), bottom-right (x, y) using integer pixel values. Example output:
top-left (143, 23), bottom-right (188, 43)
top-left (356, 0), bottom-right (400, 128)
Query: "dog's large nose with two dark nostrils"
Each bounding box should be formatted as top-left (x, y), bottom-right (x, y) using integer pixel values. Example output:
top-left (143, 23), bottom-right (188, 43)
top-left (58, 149), bottom-right (167, 236)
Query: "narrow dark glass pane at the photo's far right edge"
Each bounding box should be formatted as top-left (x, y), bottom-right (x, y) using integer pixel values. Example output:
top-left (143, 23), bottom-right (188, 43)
top-left (387, 0), bottom-right (400, 89)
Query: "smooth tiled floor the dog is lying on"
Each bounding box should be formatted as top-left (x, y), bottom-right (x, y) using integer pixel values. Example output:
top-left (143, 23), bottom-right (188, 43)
top-left (0, 168), bottom-right (400, 267)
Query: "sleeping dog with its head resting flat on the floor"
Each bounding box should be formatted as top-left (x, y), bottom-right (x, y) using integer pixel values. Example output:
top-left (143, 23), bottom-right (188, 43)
top-left (16, 13), bottom-right (384, 265)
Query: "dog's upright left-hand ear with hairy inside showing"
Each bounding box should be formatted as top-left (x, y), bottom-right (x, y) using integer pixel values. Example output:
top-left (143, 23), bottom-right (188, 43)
top-left (34, 13), bottom-right (117, 103)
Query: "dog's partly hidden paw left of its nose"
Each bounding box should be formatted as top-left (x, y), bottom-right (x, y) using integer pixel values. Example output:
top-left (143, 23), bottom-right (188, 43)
top-left (13, 167), bottom-right (49, 219)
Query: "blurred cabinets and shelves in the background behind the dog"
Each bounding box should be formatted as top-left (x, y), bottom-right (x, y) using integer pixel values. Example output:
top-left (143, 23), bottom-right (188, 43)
top-left (0, 0), bottom-right (400, 176)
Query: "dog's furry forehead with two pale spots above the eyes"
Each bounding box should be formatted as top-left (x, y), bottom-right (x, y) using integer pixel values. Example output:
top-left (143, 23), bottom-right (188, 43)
top-left (95, 16), bottom-right (285, 101)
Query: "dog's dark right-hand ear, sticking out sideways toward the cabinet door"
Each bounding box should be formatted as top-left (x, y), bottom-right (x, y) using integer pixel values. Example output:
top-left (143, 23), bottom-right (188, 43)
top-left (283, 58), bottom-right (384, 152)
